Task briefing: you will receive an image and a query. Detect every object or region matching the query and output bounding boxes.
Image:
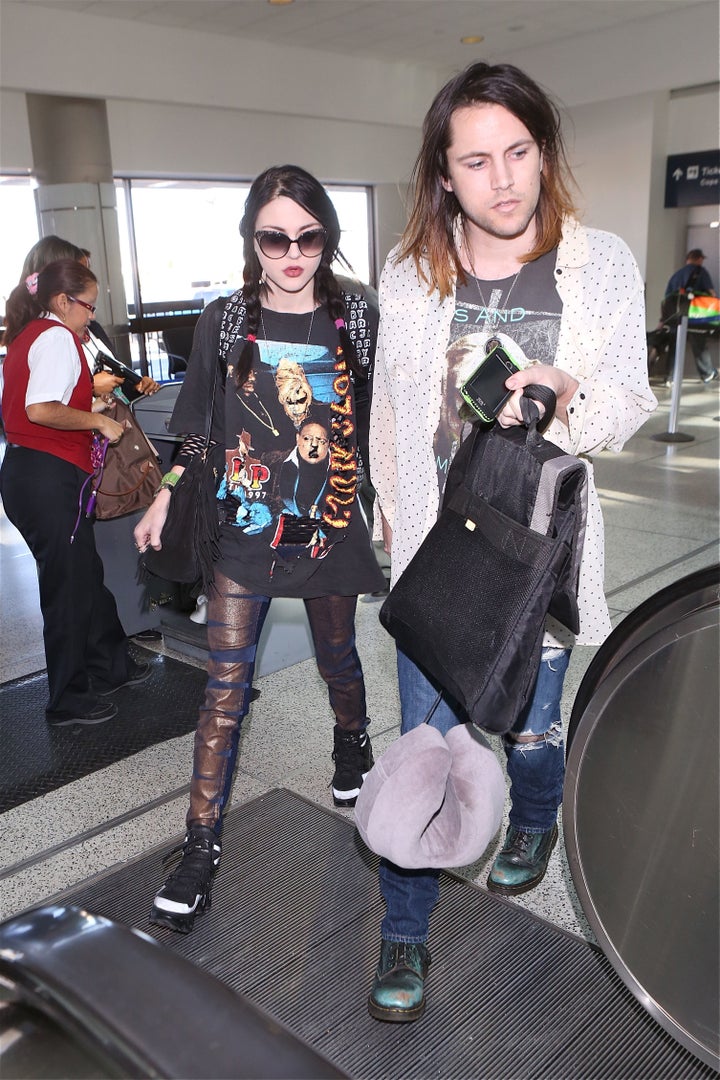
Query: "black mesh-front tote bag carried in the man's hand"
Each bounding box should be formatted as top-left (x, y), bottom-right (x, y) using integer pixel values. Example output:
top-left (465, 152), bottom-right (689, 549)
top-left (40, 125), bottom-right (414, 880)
top-left (380, 387), bottom-right (587, 733)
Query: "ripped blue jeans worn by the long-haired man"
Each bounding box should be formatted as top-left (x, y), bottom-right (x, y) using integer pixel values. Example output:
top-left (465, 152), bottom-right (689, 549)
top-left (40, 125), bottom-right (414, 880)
top-left (380, 648), bottom-right (570, 942)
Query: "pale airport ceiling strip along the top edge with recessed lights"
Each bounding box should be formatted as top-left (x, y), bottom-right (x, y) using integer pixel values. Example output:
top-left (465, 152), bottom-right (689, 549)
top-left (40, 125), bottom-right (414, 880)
top-left (5, 0), bottom-right (704, 68)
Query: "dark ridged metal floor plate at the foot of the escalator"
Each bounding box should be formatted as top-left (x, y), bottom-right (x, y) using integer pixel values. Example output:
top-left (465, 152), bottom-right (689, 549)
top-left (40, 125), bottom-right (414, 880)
top-left (55, 778), bottom-right (716, 1080)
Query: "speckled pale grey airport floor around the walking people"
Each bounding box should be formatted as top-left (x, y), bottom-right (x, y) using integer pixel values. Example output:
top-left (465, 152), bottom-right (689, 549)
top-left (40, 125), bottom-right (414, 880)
top-left (0, 378), bottom-right (720, 950)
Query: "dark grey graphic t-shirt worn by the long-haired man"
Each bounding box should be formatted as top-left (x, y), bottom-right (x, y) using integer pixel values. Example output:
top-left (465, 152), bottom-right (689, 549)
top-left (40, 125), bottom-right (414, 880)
top-left (434, 251), bottom-right (562, 496)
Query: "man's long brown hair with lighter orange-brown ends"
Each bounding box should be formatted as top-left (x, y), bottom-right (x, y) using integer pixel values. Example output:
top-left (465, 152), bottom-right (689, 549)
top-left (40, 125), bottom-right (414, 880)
top-left (397, 62), bottom-right (574, 299)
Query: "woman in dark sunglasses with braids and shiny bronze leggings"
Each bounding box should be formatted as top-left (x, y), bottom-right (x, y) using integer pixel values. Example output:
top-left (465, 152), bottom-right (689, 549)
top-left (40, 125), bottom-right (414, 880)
top-left (135, 165), bottom-right (384, 933)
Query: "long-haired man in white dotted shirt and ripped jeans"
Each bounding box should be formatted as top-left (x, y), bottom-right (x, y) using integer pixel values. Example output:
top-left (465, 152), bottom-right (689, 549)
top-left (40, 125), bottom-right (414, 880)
top-left (368, 63), bottom-right (656, 1022)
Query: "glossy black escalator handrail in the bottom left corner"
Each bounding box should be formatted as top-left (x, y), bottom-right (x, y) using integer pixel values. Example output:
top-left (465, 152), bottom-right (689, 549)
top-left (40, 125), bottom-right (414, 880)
top-left (0, 905), bottom-right (345, 1080)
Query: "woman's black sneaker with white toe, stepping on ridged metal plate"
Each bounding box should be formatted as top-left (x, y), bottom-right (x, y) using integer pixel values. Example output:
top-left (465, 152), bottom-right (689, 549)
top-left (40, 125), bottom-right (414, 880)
top-left (150, 825), bottom-right (221, 934)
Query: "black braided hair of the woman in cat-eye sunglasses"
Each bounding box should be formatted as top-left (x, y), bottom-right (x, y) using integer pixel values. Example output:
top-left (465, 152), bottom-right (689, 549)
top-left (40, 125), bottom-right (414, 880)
top-left (235, 165), bottom-right (365, 387)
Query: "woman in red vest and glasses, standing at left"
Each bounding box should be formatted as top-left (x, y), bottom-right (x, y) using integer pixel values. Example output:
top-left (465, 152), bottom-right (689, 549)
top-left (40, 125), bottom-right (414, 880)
top-left (0, 259), bottom-right (150, 727)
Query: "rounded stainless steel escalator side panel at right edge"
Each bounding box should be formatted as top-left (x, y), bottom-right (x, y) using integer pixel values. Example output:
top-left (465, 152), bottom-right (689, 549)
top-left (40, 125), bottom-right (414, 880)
top-left (563, 568), bottom-right (720, 1068)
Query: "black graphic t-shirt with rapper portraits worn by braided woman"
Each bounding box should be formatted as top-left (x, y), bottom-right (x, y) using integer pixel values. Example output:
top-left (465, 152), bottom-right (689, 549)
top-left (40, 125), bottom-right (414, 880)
top-left (218, 309), bottom-right (382, 596)
